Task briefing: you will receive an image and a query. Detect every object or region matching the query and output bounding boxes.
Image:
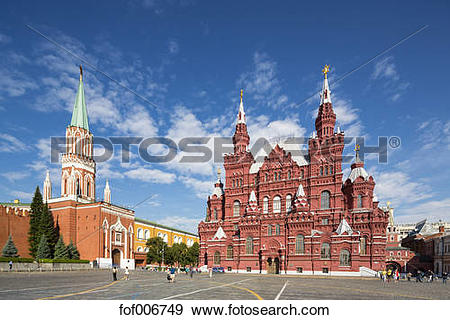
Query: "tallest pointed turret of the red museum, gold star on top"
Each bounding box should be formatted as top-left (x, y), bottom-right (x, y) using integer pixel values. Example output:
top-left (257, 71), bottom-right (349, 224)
top-left (316, 65), bottom-right (336, 138)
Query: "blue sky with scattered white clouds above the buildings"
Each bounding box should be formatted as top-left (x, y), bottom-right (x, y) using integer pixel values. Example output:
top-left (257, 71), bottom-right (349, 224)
top-left (0, 0), bottom-right (450, 231)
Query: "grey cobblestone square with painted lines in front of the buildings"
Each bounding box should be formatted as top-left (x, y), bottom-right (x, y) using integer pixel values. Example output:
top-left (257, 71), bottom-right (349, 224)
top-left (0, 270), bottom-right (450, 300)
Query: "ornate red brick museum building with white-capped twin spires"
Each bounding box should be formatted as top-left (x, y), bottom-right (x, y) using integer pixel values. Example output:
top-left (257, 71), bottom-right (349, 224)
top-left (198, 67), bottom-right (389, 275)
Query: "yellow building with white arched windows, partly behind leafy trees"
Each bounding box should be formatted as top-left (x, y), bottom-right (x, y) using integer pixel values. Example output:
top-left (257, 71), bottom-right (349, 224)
top-left (134, 218), bottom-right (199, 266)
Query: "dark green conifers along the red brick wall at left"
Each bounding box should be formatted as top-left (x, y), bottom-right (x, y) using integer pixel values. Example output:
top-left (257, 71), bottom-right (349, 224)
top-left (2, 187), bottom-right (80, 260)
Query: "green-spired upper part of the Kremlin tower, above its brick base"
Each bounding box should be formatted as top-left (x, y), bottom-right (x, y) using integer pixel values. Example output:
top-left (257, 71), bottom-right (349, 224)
top-left (61, 66), bottom-right (95, 201)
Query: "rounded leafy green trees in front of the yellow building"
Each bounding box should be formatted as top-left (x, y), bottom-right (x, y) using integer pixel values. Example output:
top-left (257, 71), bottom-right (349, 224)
top-left (146, 237), bottom-right (199, 267)
